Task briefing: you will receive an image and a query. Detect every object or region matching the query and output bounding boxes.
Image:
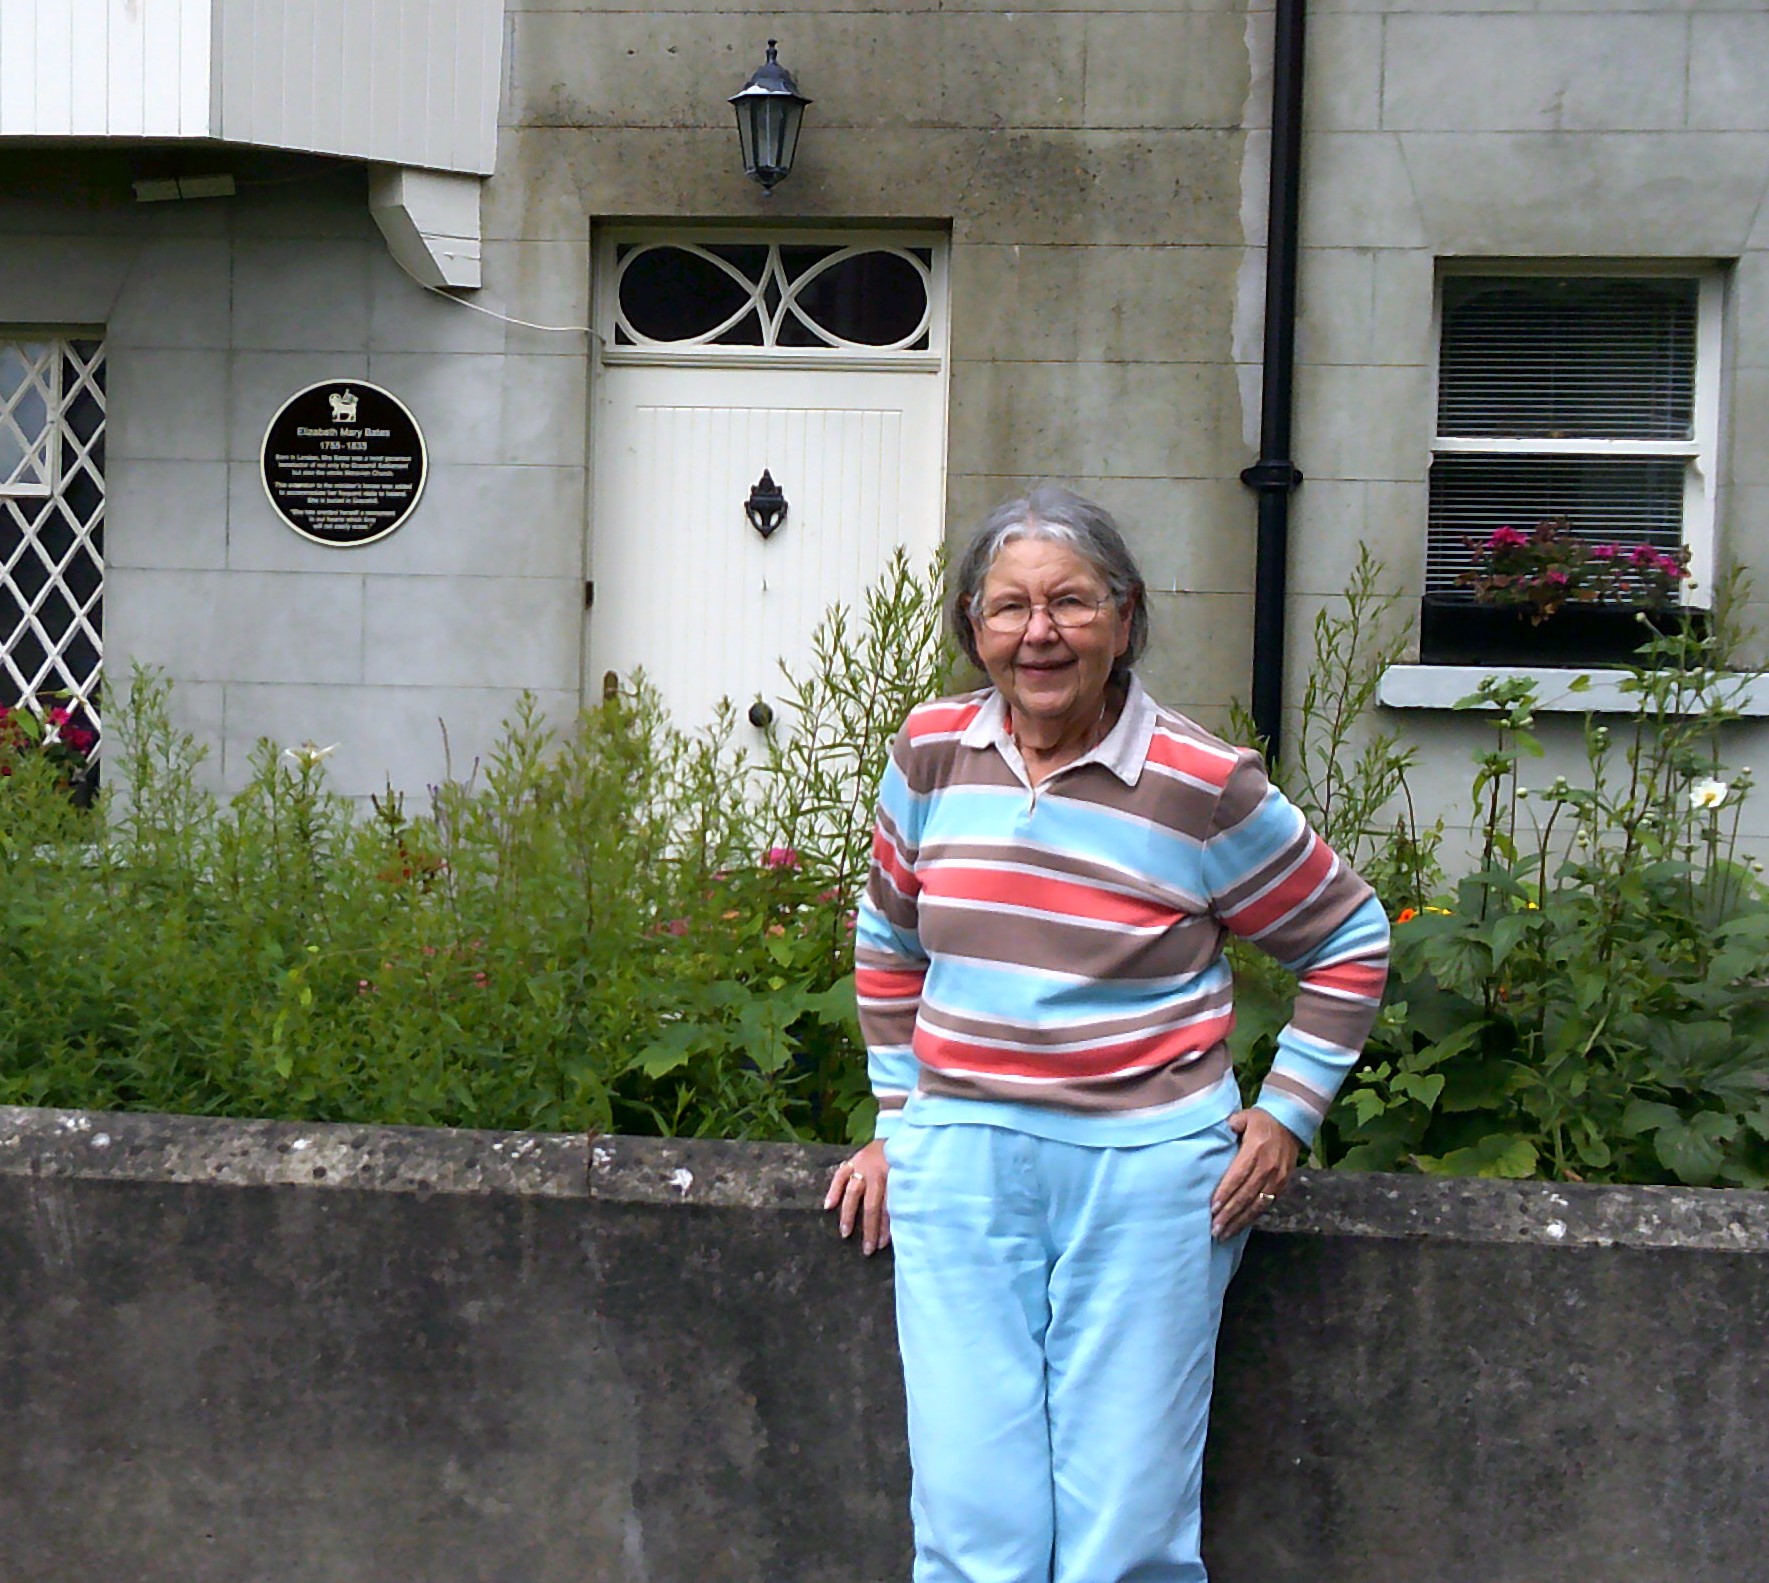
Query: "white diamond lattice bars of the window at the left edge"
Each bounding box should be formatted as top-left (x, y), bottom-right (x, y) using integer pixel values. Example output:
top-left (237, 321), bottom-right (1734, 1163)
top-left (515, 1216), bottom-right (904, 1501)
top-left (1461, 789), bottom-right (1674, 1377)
top-left (0, 325), bottom-right (106, 725)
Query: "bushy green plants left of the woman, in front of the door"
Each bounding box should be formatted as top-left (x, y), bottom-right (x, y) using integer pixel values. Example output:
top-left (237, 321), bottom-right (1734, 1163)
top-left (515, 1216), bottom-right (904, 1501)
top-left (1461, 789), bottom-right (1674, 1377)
top-left (0, 559), bottom-right (939, 1141)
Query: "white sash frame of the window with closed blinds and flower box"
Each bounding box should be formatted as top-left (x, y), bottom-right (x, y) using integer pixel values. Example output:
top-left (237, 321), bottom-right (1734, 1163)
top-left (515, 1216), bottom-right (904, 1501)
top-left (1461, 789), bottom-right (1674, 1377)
top-left (1431, 258), bottom-right (1727, 610)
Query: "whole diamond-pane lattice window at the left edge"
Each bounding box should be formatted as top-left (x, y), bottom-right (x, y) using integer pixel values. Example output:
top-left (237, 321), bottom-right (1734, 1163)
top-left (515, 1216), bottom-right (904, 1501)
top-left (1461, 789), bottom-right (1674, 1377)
top-left (0, 334), bottom-right (104, 742)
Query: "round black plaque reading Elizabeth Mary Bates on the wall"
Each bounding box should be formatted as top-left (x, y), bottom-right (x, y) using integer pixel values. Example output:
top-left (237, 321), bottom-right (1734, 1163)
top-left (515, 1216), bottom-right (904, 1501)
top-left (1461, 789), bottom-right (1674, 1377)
top-left (262, 380), bottom-right (426, 548)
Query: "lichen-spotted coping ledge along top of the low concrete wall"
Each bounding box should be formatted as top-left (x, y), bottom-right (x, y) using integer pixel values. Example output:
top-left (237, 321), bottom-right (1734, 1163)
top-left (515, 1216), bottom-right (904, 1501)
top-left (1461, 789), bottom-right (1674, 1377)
top-left (0, 1105), bottom-right (1769, 1254)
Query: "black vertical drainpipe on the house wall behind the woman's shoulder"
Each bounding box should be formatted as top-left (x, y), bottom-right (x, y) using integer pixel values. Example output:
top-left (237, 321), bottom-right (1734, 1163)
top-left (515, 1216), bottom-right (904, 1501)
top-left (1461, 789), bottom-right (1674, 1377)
top-left (1240, 0), bottom-right (1304, 764)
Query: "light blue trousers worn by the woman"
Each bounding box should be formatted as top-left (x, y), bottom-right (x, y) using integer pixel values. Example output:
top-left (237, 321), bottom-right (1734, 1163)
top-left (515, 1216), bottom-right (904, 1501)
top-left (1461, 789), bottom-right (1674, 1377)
top-left (886, 1123), bottom-right (1245, 1583)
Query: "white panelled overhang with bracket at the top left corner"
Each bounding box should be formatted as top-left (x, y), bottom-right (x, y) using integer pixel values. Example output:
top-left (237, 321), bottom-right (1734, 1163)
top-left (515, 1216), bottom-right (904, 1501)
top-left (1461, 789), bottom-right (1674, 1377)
top-left (0, 0), bottom-right (504, 285)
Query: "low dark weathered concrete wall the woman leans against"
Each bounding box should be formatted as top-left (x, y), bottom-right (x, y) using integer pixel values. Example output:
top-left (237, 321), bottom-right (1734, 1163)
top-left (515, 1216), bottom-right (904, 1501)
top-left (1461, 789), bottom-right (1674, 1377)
top-left (0, 1109), bottom-right (1769, 1583)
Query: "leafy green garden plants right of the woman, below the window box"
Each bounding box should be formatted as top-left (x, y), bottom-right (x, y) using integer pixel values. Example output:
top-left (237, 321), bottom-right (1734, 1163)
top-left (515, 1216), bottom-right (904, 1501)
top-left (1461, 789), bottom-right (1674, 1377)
top-left (1237, 557), bottom-right (1769, 1187)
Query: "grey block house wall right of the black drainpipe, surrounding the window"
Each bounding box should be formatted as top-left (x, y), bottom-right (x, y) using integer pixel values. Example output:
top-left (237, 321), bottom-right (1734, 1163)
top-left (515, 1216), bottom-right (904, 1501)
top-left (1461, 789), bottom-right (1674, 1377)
top-left (1290, 0), bottom-right (1769, 851)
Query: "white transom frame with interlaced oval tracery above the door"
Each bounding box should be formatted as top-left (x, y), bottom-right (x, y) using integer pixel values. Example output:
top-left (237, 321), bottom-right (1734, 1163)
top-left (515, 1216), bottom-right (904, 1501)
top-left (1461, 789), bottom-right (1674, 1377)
top-left (593, 226), bottom-right (948, 373)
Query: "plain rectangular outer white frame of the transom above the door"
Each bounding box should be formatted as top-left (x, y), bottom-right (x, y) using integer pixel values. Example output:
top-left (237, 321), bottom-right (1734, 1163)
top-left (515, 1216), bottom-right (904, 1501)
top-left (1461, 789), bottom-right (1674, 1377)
top-left (591, 225), bottom-right (950, 373)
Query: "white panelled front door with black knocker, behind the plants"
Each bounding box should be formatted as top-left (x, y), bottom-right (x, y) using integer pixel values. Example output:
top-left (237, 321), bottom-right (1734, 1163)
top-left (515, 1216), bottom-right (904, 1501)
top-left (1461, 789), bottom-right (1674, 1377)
top-left (586, 233), bottom-right (945, 736)
